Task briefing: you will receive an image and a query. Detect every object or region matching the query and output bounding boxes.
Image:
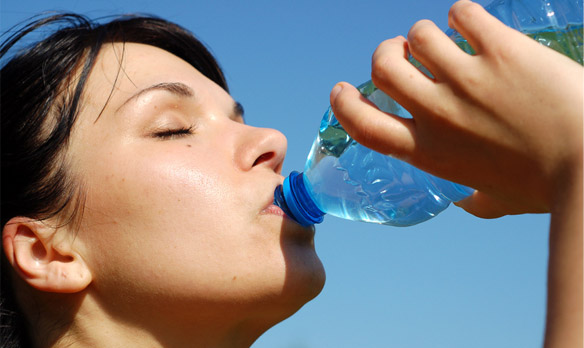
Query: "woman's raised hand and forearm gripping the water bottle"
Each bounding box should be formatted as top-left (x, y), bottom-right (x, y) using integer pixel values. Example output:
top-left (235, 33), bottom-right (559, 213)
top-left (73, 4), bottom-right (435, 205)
top-left (331, 1), bottom-right (584, 347)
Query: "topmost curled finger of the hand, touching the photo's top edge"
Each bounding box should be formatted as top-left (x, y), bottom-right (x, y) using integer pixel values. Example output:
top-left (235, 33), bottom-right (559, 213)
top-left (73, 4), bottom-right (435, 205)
top-left (448, 0), bottom-right (512, 54)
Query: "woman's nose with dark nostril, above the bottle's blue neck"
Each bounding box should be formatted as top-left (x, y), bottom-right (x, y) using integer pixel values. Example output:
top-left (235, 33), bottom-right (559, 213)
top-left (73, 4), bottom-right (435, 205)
top-left (235, 125), bottom-right (288, 174)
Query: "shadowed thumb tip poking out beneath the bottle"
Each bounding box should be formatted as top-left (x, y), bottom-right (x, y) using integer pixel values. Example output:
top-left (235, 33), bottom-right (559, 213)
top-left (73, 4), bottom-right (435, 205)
top-left (454, 191), bottom-right (525, 219)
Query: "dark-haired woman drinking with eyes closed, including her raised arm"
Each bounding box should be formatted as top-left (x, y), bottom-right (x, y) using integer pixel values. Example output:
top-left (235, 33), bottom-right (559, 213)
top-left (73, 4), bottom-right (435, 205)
top-left (1, 1), bottom-right (583, 347)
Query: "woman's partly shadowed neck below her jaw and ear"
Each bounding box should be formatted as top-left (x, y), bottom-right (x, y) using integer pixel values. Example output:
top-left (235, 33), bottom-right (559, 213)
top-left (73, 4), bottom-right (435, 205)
top-left (39, 297), bottom-right (274, 348)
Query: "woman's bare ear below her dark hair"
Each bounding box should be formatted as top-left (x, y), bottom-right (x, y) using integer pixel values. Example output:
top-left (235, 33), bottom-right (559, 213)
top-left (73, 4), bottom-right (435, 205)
top-left (2, 217), bottom-right (91, 293)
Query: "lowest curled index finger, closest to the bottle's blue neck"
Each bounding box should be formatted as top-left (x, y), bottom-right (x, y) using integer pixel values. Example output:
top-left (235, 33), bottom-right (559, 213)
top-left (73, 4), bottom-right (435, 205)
top-left (331, 82), bottom-right (415, 158)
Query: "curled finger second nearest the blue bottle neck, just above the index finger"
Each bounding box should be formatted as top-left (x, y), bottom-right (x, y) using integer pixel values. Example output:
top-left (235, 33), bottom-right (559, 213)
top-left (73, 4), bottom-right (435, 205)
top-left (371, 37), bottom-right (443, 117)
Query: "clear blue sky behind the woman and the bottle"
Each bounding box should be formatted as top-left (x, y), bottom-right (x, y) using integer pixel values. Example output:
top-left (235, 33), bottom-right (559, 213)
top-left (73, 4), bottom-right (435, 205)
top-left (0, 0), bottom-right (549, 348)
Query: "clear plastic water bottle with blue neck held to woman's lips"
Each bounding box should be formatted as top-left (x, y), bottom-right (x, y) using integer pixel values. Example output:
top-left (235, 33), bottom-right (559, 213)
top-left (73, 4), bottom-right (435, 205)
top-left (274, 0), bottom-right (583, 226)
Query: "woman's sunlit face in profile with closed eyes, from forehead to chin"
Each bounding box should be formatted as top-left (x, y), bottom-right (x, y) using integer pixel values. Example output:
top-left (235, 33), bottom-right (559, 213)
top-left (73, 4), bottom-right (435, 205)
top-left (68, 43), bottom-right (324, 328)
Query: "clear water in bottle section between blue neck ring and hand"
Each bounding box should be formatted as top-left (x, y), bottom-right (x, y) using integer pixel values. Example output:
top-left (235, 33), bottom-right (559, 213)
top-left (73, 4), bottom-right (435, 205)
top-left (304, 110), bottom-right (472, 226)
